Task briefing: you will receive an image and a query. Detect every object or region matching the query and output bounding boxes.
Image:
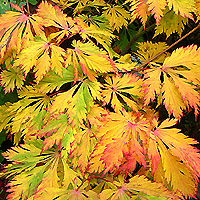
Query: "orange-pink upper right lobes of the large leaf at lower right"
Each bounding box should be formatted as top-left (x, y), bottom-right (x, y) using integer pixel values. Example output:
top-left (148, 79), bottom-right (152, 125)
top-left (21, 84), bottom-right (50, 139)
top-left (151, 119), bottom-right (200, 177)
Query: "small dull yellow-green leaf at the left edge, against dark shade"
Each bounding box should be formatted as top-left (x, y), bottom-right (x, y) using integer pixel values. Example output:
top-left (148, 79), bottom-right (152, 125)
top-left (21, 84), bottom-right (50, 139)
top-left (0, 67), bottom-right (25, 93)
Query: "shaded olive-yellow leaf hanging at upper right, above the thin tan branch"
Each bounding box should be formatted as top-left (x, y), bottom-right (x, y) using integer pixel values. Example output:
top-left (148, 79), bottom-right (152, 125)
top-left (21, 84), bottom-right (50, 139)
top-left (154, 9), bottom-right (188, 38)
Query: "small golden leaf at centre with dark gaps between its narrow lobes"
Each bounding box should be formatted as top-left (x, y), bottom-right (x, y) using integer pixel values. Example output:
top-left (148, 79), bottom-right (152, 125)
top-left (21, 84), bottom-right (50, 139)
top-left (102, 74), bottom-right (143, 112)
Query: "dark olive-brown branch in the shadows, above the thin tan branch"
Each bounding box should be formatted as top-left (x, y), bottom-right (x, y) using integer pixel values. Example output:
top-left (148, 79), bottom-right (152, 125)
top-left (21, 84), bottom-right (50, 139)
top-left (121, 24), bottom-right (156, 55)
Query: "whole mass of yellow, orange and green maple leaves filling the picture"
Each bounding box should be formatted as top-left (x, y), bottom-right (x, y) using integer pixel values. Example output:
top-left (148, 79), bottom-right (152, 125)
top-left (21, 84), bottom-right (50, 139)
top-left (0, 0), bottom-right (200, 200)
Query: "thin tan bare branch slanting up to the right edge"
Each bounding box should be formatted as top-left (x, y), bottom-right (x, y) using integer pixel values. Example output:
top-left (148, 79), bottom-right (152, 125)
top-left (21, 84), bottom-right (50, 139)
top-left (131, 23), bottom-right (200, 73)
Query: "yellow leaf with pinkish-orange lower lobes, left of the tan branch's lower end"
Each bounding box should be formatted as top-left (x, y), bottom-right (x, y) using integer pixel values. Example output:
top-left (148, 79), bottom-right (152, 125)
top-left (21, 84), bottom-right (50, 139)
top-left (65, 41), bottom-right (115, 81)
